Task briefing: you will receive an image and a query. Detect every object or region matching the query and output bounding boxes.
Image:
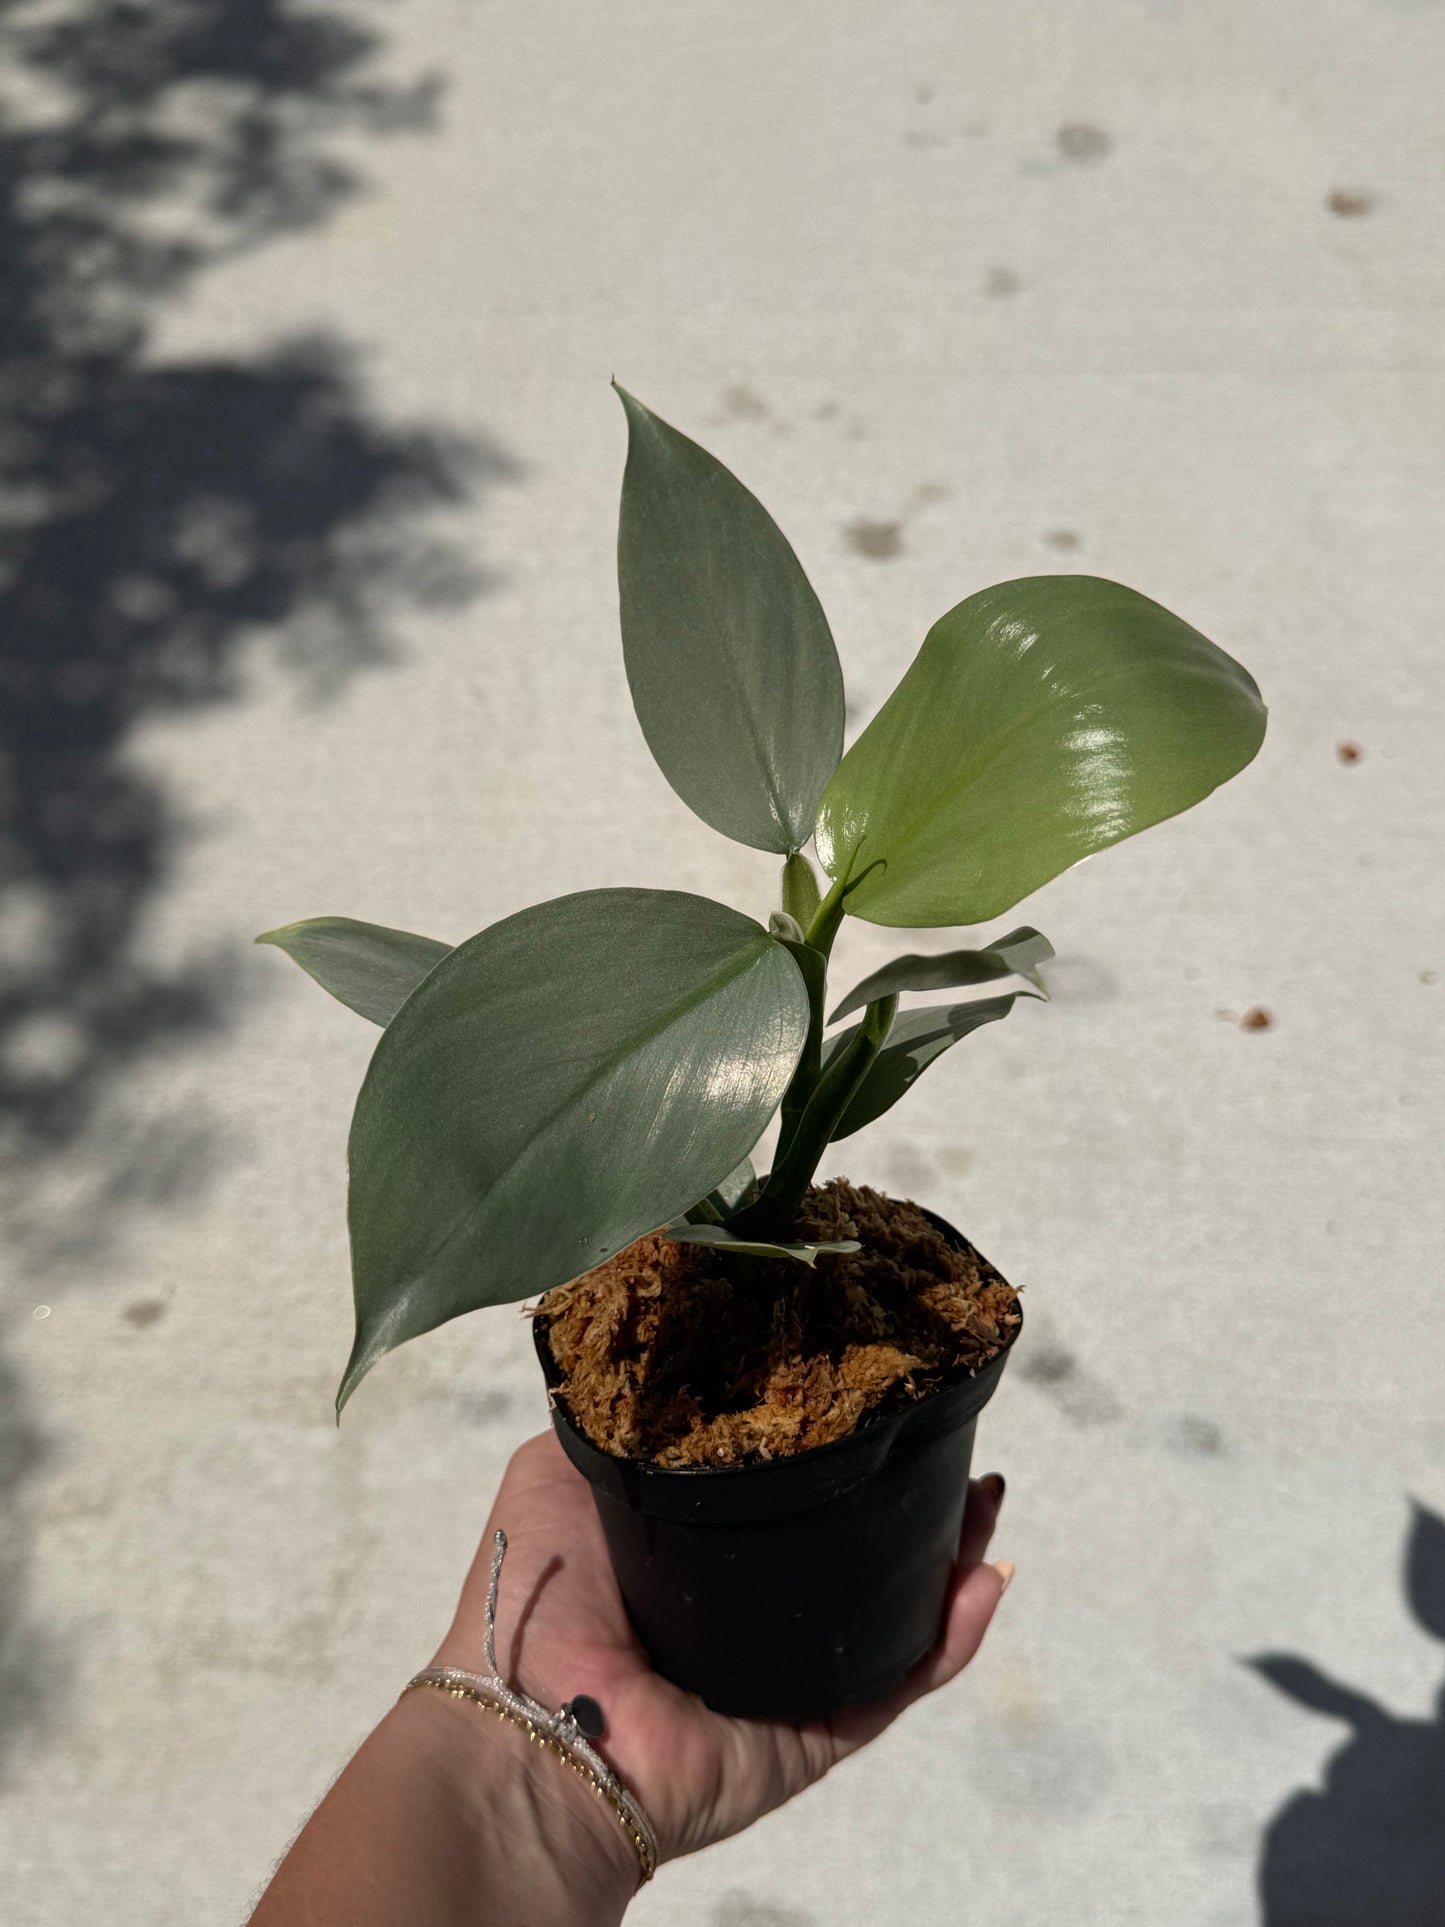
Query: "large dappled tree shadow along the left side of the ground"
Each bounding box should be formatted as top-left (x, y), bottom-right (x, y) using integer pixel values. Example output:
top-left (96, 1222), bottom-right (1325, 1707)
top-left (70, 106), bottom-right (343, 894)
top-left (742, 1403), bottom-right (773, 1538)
top-left (0, 0), bottom-right (516, 1772)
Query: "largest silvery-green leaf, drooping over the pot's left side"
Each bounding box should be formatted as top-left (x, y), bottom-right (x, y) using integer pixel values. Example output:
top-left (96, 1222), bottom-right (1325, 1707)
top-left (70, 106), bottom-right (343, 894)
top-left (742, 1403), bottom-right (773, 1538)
top-left (337, 890), bottom-right (807, 1407)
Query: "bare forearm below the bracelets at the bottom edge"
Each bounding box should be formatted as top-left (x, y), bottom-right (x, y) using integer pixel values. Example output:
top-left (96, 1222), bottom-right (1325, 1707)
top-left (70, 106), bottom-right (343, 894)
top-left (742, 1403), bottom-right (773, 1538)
top-left (250, 1690), bottom-right (638, 1927)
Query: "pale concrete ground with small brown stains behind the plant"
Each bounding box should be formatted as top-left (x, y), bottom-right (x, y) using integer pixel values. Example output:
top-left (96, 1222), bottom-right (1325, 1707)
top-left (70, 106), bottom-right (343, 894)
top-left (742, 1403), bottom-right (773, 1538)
top-left (0, 0), bottom-right (1445, 1927)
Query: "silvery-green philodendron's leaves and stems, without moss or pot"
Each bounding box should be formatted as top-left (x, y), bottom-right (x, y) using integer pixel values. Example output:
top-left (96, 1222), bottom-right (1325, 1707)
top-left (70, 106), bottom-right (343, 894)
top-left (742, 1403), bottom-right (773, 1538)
top-left (260, 389), bottom-right (1264, 1411)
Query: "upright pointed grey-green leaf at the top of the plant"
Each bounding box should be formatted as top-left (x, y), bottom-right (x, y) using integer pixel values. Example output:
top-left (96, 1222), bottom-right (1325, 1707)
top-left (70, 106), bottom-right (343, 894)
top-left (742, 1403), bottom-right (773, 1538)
top-left (617, 387), bottom-right (844, 856)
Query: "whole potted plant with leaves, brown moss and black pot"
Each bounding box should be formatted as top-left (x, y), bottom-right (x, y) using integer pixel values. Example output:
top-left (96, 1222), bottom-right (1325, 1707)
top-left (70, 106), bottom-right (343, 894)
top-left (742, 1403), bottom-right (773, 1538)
top-left (260, 391), bottom-right (1264, 1719)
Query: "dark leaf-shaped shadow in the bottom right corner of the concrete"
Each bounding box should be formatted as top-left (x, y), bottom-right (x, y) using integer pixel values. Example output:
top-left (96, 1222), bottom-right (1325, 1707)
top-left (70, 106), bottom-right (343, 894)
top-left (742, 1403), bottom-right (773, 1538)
top-left (1250, 1505), bottom-right (1445, 1927)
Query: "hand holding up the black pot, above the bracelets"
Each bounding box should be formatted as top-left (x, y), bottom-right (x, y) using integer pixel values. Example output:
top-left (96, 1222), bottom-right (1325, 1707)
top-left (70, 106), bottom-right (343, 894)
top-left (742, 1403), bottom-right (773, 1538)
top-left (435, 1432), bottom-right (1013, 1860)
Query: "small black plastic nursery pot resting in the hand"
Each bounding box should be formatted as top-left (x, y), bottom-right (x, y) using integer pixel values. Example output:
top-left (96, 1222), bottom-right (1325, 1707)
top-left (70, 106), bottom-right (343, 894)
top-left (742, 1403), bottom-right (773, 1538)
top-left (534, 1212), bottom-right (1019, 1721)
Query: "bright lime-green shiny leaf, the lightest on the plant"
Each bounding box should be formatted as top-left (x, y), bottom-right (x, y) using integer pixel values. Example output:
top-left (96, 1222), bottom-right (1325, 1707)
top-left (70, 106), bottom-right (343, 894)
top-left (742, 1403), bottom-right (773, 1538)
top-left (817, 576), bottom-right (1264, 925)
